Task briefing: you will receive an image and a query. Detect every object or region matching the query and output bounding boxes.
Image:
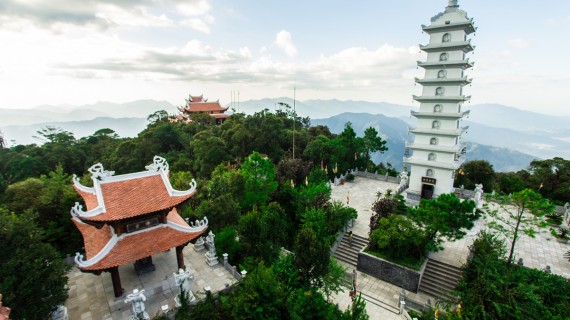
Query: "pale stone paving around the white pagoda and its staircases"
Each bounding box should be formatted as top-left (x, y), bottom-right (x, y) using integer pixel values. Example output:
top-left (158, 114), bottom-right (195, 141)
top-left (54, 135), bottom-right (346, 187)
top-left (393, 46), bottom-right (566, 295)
top-left (332, 177), bottom-right (570, 319)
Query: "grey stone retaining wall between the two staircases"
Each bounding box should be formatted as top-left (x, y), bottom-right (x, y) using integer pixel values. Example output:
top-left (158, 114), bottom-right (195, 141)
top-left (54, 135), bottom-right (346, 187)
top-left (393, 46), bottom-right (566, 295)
top-left (356, 251), bottom-right (427, 292)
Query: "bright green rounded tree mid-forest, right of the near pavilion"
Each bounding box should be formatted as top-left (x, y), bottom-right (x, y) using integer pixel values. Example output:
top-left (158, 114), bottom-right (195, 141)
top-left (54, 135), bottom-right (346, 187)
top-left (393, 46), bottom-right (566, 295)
top-left (239, 152), bottom-right (277, 209)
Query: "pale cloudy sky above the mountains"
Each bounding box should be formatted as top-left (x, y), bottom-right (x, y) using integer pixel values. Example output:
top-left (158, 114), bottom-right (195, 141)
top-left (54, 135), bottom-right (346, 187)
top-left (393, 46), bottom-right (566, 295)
top-left (0, 0), bottom-right (570, 116)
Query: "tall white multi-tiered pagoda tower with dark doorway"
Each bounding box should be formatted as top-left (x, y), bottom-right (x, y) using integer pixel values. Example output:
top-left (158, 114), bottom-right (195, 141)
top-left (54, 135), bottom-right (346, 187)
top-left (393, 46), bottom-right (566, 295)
top-left (404, 0), bottom-right (476, 200)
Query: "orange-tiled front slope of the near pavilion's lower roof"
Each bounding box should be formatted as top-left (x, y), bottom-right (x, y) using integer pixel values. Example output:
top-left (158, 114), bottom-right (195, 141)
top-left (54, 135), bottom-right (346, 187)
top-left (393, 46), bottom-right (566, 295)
top-left (80, 210), bottom-right (206, 270)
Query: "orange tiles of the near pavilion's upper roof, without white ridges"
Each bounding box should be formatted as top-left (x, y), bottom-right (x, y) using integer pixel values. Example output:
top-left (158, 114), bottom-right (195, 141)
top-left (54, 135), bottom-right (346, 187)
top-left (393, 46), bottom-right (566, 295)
top-left (79, 174), bottom-right (195, 221)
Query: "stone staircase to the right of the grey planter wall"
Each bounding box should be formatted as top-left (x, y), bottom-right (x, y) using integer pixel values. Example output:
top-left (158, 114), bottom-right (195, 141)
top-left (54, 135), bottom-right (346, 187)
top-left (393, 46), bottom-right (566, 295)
top-left (418, 259), bottom-right (461, 300)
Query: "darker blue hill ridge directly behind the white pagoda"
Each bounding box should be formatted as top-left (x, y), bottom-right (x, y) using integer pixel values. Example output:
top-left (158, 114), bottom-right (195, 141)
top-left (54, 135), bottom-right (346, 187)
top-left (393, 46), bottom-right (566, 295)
top-left (311, 113), bottom-right (536, 171)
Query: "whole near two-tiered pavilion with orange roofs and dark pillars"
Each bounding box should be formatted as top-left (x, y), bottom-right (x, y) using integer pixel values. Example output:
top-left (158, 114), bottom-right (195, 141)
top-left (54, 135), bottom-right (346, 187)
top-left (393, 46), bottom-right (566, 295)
top-left (71, 156), bottom-right (208, 297)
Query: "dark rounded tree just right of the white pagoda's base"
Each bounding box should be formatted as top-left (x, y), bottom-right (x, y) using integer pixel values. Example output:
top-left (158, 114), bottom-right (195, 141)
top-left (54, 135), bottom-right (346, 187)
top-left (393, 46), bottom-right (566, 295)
top-left (455, 160), bottom-right (495, 192)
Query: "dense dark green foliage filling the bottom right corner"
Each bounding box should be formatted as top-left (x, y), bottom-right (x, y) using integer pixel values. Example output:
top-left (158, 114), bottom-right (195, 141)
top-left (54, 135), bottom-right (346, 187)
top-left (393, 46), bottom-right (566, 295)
top-left (458, 232), bottom-right (570, 319)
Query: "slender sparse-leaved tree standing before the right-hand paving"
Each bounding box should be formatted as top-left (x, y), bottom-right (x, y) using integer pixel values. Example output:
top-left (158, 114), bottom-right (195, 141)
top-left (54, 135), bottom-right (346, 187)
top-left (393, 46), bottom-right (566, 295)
top-left (485, 189), bottom-right (554, 268)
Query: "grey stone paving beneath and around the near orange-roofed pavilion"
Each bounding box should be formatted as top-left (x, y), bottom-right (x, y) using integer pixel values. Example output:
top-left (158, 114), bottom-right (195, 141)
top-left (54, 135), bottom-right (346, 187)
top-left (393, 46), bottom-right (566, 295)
top-left (65, 244), bottom-right (236, 320)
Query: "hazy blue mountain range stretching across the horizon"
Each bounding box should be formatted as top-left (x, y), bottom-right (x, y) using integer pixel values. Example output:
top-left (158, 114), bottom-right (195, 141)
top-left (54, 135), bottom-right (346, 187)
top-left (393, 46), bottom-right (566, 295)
top-left (0, 98), bottom-right (570, 171)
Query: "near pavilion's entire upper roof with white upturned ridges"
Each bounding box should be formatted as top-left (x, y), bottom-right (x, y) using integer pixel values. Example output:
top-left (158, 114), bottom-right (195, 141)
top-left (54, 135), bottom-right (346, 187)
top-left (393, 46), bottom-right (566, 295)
top-left (71, 156), bottom-right (196, 222)
